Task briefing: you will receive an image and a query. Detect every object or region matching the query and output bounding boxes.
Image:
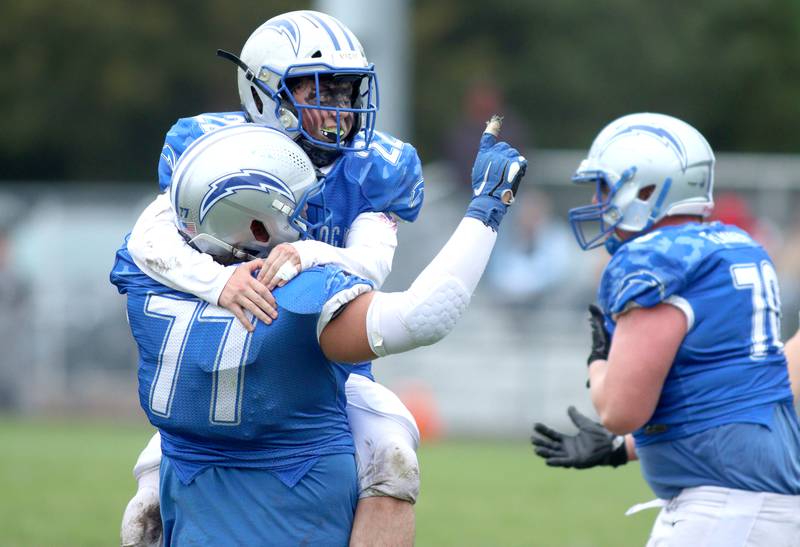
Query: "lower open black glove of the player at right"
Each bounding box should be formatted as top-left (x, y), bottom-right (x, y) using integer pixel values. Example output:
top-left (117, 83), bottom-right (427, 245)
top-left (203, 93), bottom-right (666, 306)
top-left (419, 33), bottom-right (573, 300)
top-left (531, 406), bottom-right (628, 469)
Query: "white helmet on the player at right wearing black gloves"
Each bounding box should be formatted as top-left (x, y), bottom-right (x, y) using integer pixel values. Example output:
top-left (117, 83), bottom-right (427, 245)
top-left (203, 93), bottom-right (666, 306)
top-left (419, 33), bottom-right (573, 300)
top-left (569, 113), bottom-right (715, 252)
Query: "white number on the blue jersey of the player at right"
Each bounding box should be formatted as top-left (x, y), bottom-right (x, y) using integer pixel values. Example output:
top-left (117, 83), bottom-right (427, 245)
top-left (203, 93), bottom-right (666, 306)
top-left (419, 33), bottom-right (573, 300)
top-left (731, 260), bottom-right (783, 359)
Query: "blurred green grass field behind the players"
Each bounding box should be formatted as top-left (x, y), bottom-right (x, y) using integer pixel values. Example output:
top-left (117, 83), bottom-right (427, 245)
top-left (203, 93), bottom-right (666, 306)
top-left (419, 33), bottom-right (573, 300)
top-left (0, 417), bottom-right (655, 547)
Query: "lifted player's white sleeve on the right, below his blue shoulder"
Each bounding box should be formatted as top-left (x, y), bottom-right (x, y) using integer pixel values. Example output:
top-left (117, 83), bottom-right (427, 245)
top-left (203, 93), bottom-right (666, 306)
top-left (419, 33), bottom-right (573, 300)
top-left (292, 213), bottom-right (397, 288)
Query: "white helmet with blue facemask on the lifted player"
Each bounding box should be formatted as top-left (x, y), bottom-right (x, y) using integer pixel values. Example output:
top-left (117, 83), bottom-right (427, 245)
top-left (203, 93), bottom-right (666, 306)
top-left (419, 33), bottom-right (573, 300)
top-left (218, 11), bottom-right (378, 163)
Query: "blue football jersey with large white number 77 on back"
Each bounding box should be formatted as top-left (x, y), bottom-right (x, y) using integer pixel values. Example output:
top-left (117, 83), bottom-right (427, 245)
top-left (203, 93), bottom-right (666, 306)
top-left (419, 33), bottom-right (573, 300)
top-left (111, 242), bottom-right (371, 484)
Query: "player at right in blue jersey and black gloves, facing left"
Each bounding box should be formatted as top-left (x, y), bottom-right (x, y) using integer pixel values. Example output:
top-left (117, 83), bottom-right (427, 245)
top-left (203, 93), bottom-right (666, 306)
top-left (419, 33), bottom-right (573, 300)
top-left (533, 114), bottom-right (800, 546)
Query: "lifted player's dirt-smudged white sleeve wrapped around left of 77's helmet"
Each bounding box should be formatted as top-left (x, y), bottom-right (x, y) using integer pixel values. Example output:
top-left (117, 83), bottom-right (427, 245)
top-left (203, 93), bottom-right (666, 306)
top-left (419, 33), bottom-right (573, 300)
top-left (128, 193), bottom-right (236, 305)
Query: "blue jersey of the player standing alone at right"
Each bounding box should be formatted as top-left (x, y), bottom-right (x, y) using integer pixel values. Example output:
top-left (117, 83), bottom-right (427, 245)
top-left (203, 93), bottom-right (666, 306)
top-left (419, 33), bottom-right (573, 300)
top-left (598, 223), bottom-right (792, 447)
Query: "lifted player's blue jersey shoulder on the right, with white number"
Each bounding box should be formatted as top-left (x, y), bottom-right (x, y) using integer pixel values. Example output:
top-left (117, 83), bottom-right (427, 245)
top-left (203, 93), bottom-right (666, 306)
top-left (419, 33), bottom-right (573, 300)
top-left (343, 131), bottom-right (425, 222)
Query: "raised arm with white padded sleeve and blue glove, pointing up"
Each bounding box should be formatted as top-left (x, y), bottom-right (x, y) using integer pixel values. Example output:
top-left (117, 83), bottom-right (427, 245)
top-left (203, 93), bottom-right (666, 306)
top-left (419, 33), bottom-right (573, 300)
top-left (320, 119), bottom-right (527, 363)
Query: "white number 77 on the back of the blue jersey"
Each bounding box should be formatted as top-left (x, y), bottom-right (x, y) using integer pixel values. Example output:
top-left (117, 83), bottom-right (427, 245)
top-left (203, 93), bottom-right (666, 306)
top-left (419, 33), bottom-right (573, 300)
top-left (144, 294), bottom-right (252, 425)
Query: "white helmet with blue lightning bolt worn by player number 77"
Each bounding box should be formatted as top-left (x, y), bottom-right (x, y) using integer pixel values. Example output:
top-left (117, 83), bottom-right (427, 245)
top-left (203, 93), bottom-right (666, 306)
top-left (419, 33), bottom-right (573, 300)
top-left (170, 124), bottom-right (324, 264)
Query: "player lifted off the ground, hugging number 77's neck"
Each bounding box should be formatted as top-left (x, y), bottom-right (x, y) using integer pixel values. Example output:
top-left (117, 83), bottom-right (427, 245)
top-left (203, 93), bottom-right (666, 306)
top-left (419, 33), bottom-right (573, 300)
top-left (122, 11), bottom-right (450, 545)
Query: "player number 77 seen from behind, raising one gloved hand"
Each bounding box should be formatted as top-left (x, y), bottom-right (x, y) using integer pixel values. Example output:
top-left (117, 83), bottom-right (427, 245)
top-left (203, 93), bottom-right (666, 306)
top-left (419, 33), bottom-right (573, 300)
top-left (111, 124), bottom-right (527, 545)
